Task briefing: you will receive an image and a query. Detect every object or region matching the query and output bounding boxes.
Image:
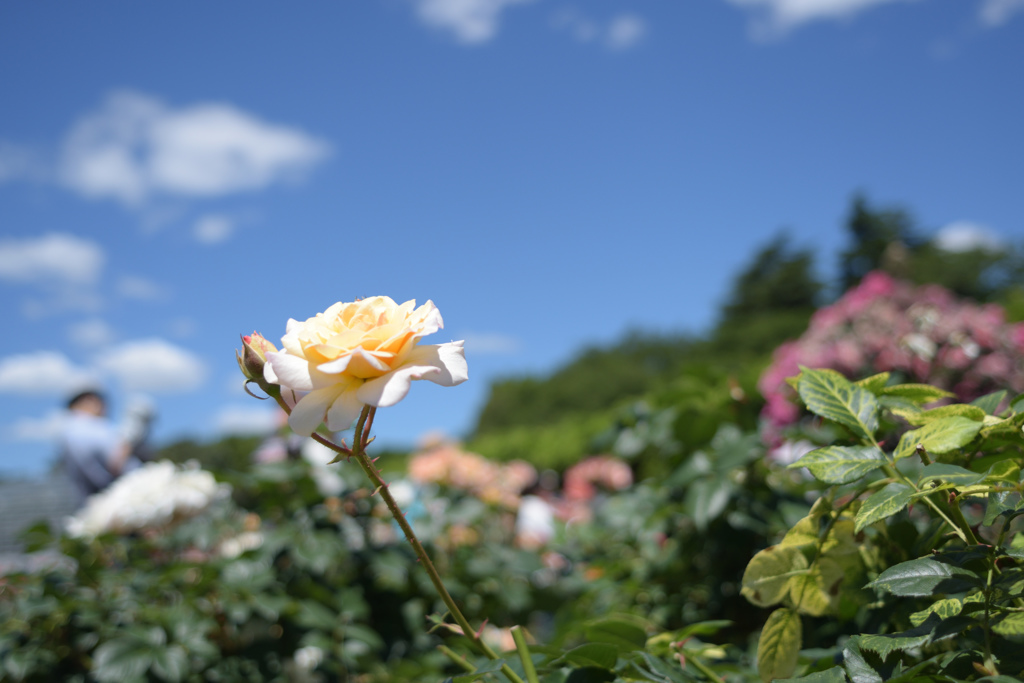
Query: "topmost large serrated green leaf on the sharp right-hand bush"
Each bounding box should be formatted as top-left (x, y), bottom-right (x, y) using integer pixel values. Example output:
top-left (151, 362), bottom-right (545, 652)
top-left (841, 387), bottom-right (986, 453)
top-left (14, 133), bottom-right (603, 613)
top-left (797, 368), bottom-right (879, 440)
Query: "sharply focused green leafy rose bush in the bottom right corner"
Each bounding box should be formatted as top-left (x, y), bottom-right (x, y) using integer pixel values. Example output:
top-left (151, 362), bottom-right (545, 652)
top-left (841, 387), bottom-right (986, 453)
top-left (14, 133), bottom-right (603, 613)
top-left (743, 369), bottom-right (1024, 681)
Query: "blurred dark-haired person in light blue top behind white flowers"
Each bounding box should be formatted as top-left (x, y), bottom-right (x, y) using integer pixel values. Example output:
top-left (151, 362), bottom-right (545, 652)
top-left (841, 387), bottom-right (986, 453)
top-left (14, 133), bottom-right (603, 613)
top-left (59, 389), bottom-right (155, 505)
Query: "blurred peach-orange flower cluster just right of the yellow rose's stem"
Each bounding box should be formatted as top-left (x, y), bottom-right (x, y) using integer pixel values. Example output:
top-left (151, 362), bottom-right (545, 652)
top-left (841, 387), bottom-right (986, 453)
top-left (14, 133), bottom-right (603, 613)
top-left (409, 443), bottom-right (537, 510)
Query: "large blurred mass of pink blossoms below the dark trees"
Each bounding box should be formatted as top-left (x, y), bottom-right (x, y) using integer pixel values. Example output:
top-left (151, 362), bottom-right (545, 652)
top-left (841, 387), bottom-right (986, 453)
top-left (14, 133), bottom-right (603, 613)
top-left (758, 271), bottom-right (1024, 438)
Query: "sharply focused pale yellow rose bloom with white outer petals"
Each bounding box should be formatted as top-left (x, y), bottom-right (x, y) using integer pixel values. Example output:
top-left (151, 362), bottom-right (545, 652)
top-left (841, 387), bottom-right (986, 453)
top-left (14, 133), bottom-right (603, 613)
top-left (263, 297), bottom-right (468, 436)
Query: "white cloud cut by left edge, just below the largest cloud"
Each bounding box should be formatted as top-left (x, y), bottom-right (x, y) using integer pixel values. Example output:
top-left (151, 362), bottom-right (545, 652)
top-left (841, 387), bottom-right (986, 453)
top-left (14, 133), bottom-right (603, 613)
top-left (0, 233), bottom-right (106, 285)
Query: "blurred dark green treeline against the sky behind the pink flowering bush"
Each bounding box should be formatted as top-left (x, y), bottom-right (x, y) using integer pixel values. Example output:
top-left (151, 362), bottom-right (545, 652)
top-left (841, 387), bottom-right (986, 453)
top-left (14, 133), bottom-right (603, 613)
top-left (469, 197), bottom-right (1024, 468)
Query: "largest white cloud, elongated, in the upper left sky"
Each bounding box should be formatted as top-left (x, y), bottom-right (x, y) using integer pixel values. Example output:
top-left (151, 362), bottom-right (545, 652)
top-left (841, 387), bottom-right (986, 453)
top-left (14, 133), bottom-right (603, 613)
top-left (59, 92), bottom-right (330, 206)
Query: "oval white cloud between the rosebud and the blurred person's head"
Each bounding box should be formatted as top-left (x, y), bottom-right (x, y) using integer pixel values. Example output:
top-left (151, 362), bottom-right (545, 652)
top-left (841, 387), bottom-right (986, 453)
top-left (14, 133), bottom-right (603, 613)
top-left (96, 339), bottom-right (207, 393)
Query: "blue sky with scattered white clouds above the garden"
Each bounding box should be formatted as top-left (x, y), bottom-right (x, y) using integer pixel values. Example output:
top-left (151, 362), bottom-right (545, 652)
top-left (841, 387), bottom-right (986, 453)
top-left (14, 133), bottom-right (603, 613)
top-left (0, 0), bottom-right (1024, 475)
